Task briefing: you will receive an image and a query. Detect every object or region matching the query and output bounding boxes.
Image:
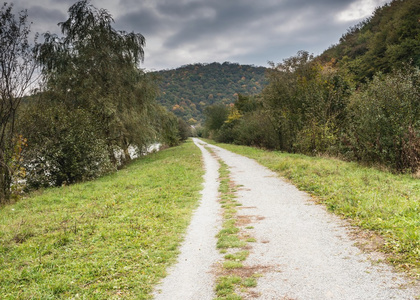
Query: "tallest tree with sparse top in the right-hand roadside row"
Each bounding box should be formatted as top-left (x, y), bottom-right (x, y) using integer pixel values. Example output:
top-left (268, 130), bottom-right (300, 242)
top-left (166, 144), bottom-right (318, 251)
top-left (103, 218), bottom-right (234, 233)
top-left (262, 51), bottom-right (351, 154)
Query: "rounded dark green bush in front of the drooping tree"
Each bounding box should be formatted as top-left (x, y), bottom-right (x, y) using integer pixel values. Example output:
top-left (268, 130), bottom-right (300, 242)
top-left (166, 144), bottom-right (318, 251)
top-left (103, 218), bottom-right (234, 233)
top-left (21, 103), bottom-right (111, 188)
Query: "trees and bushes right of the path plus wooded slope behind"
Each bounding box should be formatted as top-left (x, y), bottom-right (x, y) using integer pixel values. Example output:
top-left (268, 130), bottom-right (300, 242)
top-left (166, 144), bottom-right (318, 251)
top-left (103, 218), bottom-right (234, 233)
top-left (203, 0), bottom-right (420, 173)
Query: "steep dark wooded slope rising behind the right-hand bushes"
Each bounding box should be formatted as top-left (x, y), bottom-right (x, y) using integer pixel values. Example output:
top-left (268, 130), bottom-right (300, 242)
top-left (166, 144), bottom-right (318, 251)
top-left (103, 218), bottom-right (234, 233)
top-left (320, 0), bottom-right (420, 82)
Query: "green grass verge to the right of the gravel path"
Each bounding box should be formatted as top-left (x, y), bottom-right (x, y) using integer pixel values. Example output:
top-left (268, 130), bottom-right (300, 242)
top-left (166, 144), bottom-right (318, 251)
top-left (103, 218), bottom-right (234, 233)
top-left (209, 141), bottom-right (420, 278)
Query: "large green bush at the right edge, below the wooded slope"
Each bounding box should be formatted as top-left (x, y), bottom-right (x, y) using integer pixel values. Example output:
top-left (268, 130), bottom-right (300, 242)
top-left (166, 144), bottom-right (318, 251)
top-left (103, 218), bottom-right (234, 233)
top-left (346, 68), bottom-right (420, 172)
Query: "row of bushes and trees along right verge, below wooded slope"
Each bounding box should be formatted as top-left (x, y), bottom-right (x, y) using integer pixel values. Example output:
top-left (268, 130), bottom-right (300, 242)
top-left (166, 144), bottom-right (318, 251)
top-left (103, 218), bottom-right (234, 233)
top-left (202, 60), bottom-right (420, 173)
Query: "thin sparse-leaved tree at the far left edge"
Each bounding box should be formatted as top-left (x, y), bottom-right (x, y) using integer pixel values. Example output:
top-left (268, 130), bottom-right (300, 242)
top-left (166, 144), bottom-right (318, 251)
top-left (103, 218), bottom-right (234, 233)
top-left (0, 3), bottom-right (36, 204)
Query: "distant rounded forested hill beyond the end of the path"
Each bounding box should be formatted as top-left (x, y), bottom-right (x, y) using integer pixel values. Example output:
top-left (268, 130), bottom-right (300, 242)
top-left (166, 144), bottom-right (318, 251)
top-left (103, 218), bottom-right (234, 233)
top-left (155, 62), bottom-right (266, 125)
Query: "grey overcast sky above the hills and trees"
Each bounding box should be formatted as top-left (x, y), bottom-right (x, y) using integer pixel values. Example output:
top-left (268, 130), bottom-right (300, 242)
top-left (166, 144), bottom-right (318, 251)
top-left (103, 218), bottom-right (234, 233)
top-left (6, 0), bottom-right (390, 70)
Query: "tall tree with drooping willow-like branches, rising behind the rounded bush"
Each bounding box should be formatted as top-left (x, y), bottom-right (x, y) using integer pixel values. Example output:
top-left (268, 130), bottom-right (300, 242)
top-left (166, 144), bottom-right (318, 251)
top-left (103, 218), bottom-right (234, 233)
top-left (37, 0), bottom-right (156, 165)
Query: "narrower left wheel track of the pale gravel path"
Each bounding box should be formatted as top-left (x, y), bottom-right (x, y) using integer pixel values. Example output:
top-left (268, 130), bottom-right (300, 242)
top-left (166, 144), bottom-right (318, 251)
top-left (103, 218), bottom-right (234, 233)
top-left (154, 139), bottom-right (222, 300)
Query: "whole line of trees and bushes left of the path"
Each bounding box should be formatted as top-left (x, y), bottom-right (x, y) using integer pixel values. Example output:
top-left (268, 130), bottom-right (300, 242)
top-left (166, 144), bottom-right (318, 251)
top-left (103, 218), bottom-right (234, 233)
top-left (0, 0), bottom-right (189, 204)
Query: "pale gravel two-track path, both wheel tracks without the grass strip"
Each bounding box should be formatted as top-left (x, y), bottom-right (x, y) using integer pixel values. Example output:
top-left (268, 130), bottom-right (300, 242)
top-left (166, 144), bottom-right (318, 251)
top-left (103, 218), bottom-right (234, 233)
top-left (153, 139), bottom-right (420, 300)
